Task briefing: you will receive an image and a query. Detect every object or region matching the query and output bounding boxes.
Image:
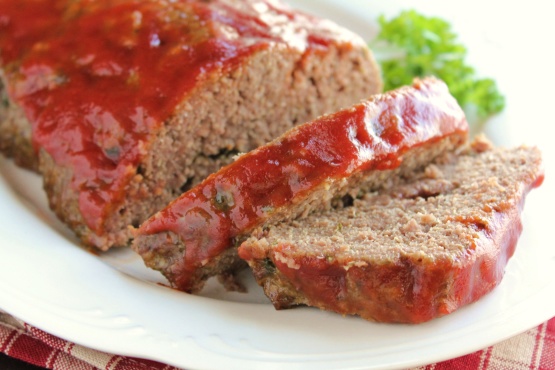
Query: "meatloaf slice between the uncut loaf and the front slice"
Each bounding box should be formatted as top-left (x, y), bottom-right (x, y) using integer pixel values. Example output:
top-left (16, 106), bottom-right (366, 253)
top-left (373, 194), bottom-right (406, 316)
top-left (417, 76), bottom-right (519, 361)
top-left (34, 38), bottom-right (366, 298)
top-left (133, 78), bottom-right (468, 292)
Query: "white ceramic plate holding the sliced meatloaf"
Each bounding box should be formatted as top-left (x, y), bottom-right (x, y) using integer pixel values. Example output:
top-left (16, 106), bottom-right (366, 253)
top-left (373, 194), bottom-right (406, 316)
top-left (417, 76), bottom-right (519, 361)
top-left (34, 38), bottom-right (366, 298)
top-left (0, 0), bottom-right (555, 369)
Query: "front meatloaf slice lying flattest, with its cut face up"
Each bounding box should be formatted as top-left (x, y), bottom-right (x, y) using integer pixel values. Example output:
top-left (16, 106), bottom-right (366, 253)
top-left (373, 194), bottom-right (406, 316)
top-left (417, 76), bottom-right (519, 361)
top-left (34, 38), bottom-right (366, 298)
top-left (239, 139), bottom-right (543, 323)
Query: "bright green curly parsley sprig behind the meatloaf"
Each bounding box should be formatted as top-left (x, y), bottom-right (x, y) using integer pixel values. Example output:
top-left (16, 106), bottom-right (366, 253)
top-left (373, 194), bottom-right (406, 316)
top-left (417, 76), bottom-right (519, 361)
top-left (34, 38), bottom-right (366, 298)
top-left (371, 10), bottom-right (505, 121)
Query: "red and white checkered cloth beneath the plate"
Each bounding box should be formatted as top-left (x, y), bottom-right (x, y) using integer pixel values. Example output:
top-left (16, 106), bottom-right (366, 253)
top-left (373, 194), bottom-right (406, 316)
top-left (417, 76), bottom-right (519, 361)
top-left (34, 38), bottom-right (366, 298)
top-left (0, 311), bottom-right (555, 370)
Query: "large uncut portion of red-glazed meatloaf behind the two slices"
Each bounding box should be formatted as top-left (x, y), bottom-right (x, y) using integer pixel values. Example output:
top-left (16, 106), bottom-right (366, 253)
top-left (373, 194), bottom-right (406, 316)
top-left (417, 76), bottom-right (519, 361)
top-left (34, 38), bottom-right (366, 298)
top-left (0, 0), bottom-right (381, 250)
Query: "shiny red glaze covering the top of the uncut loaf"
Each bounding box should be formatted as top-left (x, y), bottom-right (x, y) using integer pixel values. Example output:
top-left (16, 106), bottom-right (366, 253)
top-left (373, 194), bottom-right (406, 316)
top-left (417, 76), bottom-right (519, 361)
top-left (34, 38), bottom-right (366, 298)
top-left (0, 0), bottom-right (338, 233)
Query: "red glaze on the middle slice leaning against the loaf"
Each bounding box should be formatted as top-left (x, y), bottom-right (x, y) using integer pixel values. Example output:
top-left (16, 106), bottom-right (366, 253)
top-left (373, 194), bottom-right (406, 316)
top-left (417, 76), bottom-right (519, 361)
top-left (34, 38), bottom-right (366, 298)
top-left (139, 79), bottom-right (468, 290)
